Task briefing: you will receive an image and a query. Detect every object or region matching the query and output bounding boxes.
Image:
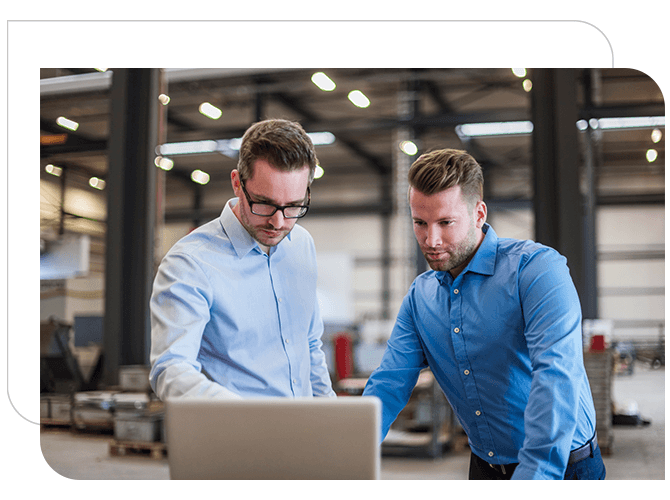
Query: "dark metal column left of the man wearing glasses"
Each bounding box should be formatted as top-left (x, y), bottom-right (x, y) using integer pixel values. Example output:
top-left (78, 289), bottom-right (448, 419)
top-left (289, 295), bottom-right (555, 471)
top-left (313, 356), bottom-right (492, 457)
top-left (103, 69), bottom-right (160, 385)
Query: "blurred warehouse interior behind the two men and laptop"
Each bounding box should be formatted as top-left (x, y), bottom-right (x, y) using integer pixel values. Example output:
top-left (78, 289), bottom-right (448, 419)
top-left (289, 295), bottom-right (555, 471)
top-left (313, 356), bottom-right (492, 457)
top-left (39, 68), bottom-right (665, 480)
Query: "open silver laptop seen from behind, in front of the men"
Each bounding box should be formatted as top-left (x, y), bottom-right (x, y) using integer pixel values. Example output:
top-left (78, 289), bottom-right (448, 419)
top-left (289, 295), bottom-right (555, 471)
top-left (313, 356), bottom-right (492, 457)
top-left (165, 396), bottom-right (381, 480)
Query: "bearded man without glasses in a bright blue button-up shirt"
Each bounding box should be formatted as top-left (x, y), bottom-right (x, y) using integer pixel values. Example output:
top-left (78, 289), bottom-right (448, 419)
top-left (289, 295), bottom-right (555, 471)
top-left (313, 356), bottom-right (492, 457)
top-left (363, 149), bottom-right (605, 479)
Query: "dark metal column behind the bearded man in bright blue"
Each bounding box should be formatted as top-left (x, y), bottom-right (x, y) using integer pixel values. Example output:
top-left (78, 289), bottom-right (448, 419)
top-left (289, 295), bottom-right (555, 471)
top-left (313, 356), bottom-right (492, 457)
top-left (532, 69), bottom-right (597, 318)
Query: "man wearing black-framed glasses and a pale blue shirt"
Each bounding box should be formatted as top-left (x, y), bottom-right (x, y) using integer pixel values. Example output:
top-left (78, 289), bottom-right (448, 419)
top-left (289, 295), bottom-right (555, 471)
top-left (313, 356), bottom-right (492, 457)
top-left (150, 120), bottom-right (335, 399)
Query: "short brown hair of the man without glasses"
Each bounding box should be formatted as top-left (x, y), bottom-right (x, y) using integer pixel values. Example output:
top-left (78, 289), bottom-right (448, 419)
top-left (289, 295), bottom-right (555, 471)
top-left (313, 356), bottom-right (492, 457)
top-left (408, 149), bottom-right (484, 201)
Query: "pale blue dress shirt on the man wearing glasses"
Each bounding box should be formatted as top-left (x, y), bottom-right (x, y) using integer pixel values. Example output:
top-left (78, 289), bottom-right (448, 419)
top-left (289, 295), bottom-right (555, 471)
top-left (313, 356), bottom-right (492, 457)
top-left (150, 198), bottom-right (335, 400)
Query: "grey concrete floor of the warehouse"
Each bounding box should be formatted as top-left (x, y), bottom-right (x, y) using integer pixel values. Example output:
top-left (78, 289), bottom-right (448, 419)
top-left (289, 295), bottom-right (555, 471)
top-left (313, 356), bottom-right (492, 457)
top-left (40, 365), bottom-right (665, 480)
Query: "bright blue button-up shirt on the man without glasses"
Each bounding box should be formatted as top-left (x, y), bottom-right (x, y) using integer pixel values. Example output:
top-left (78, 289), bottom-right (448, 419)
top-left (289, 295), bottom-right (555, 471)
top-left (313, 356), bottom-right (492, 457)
top-left (364, 224), bottom-right (595, 479)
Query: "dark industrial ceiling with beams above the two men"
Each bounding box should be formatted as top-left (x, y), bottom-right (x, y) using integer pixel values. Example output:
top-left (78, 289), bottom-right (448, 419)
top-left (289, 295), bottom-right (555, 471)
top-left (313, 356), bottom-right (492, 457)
top-left (40, 68), bottom-right (665, 237)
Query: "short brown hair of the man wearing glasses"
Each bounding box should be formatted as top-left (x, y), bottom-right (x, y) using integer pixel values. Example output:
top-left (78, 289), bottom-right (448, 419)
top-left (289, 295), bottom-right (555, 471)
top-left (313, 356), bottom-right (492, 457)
top-left (237, 119), bottom-right (318, 183)
